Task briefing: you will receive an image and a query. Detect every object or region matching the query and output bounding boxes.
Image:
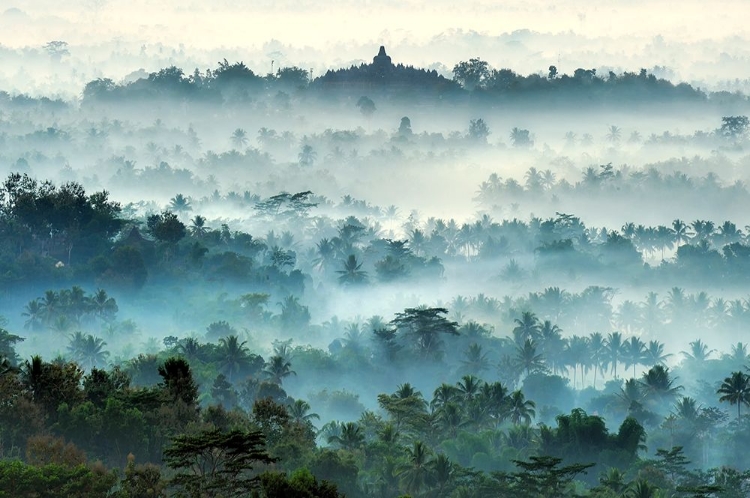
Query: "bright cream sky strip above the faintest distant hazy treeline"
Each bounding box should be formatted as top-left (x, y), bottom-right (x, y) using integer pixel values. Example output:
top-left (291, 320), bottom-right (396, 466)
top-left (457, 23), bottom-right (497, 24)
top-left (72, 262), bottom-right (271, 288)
top-left (0, 0), bottom-right (750, 48)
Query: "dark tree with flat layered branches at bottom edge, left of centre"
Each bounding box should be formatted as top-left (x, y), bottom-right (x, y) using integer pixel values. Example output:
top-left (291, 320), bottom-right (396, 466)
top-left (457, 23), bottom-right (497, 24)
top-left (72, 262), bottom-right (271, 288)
top-left (164, 429), bottom-right (276, 497)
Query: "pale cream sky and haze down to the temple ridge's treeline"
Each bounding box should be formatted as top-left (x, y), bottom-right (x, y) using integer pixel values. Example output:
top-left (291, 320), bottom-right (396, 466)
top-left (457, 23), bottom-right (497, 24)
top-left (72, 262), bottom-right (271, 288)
top-left (0, 0), bottom-right (750, 96)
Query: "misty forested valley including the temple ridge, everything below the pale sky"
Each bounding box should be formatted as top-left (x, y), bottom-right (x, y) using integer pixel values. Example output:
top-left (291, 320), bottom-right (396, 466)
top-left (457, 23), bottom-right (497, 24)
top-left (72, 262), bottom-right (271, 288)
top-left (0, 42), bottom-right (750, 498)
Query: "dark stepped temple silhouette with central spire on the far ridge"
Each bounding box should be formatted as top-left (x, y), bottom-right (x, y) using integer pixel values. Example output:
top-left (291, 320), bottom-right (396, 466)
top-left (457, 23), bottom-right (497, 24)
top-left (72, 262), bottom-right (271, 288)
top-left (315, 45), bottom-right (460, 100)
